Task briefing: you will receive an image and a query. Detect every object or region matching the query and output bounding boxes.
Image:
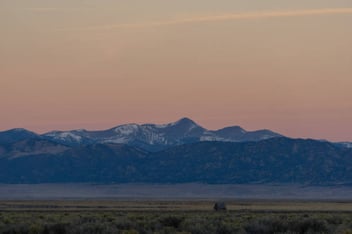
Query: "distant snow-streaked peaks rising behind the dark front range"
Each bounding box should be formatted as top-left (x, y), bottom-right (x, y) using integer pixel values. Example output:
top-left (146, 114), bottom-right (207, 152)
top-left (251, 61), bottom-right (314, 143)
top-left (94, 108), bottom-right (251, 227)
top-left (0, 118), bottom-right (281, 151)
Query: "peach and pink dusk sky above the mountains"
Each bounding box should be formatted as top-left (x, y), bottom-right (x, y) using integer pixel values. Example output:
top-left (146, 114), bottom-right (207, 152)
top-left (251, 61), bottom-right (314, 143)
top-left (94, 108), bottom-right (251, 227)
top-left (0, 0), bottom-right (352, 141)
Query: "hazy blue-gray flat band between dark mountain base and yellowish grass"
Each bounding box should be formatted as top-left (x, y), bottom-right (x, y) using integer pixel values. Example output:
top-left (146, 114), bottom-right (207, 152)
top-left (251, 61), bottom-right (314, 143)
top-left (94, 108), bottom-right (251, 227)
top-left (0, 183), bottom-right (352, 201)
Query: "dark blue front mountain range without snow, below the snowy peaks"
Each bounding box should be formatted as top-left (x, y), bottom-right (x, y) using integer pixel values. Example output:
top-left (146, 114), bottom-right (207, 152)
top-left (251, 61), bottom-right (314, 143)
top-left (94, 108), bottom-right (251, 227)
top-left (0, 137), bottom-right (352, 185)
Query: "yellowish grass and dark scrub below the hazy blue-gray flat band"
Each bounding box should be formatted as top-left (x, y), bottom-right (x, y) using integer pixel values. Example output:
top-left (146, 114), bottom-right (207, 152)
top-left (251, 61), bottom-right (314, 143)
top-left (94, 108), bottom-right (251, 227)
top-left (0, 200), bottom-right (352, 234)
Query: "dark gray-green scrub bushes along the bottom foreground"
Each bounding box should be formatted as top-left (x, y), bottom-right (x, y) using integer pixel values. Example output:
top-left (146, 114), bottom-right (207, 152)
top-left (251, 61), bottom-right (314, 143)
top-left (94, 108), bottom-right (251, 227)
top-left (0, 211), bottom-right (352, 234)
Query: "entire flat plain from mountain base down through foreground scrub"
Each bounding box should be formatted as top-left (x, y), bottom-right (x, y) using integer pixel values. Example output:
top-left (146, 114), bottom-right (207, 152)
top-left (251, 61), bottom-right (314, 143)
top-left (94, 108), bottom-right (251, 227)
top-left (0, 183), bottom-right (352, 234)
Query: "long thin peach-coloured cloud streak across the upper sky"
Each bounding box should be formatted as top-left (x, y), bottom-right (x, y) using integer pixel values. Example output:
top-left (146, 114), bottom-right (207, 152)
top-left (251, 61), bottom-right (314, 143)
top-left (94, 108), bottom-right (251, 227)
top-left (57, 8), bottom-right (352, 30)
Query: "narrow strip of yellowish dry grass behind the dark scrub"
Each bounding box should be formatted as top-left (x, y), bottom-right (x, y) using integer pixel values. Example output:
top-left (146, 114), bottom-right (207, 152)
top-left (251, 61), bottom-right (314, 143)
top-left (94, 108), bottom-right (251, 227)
top-left (0, 200), bottom-right (352, 212)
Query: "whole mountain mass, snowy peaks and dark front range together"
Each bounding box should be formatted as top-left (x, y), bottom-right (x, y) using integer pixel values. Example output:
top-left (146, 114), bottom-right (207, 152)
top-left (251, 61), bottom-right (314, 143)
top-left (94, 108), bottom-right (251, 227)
top-left (0, 118), bottom-right (352, 185)
